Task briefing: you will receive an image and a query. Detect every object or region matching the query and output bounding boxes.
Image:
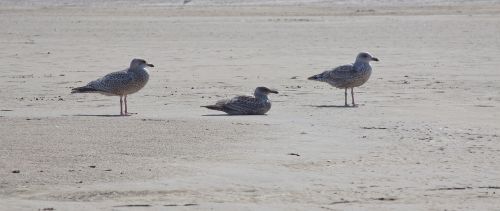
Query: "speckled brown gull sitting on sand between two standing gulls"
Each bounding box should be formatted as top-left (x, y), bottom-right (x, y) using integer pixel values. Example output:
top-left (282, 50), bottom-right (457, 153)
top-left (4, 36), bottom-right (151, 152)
top-left (201, 86), bottom-right (278, 115)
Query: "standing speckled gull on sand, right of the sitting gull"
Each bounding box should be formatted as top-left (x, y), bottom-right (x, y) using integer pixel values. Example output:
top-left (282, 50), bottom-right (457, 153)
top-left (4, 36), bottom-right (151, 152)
top-left (308, 52), bottom-right (378, 107)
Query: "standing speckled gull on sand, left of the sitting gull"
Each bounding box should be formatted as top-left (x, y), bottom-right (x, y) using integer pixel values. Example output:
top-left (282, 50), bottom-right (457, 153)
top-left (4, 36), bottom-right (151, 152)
top-left (71, 59), bottom-right (154, 116)
